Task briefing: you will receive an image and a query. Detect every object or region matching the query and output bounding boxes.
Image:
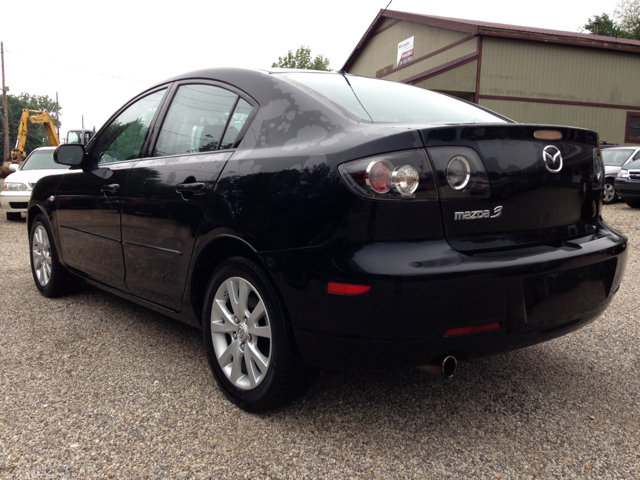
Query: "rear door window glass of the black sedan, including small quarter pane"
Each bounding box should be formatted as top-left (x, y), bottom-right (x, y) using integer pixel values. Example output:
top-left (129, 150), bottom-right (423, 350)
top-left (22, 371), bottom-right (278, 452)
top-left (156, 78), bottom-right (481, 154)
top-left (153, 85), bottom-right (251, 157)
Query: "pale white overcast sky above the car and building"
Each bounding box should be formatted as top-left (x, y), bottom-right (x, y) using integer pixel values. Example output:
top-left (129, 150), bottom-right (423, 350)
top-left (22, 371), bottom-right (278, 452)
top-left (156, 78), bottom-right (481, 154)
top-left (0, 0), bottom-right (617, 136)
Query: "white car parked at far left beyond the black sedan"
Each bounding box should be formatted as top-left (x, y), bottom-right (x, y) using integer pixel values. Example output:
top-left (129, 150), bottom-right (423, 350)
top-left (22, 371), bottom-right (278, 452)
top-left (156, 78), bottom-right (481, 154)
top-left (0, 147), bottom-right (69, 220)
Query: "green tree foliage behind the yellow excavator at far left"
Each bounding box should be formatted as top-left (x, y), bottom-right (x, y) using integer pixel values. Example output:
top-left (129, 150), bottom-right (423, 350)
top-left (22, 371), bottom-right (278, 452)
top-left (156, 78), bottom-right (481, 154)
top-left (0, 93), bottom-right (62, 163)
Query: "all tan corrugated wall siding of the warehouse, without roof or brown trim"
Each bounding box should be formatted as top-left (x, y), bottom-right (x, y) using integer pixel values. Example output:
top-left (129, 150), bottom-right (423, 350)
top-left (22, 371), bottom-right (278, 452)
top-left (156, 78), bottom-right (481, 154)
top-left (349, 19), bottom-right (640, 144)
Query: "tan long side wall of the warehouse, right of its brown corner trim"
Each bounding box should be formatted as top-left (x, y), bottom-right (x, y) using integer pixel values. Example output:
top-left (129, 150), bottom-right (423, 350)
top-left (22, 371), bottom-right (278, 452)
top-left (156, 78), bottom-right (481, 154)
top-left (479, 38), bottom-right (640, 144)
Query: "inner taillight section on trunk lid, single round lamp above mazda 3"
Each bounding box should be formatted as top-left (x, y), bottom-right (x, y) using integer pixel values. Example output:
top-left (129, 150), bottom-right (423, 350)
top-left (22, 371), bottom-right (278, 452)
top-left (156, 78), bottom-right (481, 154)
top-left (427, 147), bottom-right (489, 199)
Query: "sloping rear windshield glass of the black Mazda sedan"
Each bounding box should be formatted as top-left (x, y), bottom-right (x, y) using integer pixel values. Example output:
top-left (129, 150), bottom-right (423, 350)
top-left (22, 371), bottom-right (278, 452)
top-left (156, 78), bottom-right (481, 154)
top-left (281, 72), bottom-right (506, 124)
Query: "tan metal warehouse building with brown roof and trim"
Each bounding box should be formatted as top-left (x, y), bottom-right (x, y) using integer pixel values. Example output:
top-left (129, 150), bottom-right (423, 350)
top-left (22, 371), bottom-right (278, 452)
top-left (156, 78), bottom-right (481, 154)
top-left (343, 10), bottom-right (640, 144)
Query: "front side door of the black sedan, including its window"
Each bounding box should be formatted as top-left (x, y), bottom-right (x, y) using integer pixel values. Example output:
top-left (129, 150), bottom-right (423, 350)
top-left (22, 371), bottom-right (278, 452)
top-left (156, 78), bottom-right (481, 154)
top-left (56, 88), bottom-right (167, 291)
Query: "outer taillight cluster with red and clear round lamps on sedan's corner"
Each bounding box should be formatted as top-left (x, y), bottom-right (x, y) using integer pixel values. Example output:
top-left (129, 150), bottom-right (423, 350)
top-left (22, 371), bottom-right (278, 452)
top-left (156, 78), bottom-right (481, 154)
top-left (338, 150), bottom-right (438, 200)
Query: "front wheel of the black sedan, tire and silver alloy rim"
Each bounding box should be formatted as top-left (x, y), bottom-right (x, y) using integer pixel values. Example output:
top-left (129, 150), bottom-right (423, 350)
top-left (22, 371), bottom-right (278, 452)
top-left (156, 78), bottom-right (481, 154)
top-left (29, 215), bottom-right (79, 297)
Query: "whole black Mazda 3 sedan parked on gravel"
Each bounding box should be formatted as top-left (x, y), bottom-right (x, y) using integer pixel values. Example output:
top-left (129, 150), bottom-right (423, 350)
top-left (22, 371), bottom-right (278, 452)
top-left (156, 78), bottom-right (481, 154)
top-left (28, 69), bottom-right (627, 411)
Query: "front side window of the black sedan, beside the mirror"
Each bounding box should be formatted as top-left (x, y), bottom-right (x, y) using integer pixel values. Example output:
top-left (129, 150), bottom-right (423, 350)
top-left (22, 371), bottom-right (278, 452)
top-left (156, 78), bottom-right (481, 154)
top-left (92, 90), bottom-right (166, 164)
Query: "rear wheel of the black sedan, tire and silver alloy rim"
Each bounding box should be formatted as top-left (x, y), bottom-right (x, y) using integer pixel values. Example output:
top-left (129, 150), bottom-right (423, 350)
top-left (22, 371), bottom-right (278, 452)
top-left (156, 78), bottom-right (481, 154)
top-left (202, 257), bottom-right (312, 413)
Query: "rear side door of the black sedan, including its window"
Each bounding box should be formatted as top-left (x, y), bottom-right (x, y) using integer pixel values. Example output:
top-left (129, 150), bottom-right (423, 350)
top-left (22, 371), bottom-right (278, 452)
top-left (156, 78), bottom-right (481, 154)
top-left (122, 82), bottom-right (253, 311)
